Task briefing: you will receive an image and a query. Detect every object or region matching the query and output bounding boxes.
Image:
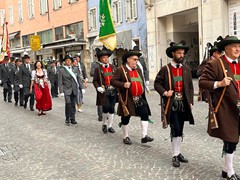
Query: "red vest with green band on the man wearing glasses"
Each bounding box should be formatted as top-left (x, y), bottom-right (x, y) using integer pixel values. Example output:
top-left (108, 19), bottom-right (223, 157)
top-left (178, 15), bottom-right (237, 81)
top-left (128, 70), bottom-right (143, 96)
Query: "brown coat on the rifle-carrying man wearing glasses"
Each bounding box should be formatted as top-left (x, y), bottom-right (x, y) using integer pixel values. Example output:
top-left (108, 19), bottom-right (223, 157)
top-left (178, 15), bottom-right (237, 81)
top-left (111, 65), bottom-right (151, 116)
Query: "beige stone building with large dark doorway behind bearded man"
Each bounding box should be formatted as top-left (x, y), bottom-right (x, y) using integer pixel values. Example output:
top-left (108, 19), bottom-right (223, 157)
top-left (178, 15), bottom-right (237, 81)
top-left (146, 0), bottom-right (240, 79)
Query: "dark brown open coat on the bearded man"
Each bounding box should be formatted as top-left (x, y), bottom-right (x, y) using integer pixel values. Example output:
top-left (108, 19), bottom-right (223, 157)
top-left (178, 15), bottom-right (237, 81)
top-left (154, 63), bottom-right (194, 124)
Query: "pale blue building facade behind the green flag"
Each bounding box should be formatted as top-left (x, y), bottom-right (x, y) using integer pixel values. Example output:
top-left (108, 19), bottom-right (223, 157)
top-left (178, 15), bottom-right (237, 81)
top-left (87, 0), bottom-right (147, 65)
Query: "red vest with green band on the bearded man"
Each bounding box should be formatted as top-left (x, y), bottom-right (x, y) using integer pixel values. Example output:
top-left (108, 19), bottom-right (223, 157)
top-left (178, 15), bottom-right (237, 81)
top-left (172, 66), bottom-right (183, 92)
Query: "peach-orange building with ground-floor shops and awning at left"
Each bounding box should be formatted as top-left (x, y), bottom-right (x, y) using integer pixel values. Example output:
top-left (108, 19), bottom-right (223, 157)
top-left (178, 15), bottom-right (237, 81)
top-left (0, 0), bottom-right (88, 64)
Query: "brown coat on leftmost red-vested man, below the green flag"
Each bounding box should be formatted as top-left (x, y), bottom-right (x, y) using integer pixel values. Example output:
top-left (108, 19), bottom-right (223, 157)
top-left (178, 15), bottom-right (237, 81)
top-left (93, 64), bottom-right (115, 106)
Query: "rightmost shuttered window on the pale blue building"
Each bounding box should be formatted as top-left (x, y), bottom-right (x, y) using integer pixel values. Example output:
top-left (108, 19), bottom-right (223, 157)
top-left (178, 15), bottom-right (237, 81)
top-left (125, 0), bottom-right (137, 21)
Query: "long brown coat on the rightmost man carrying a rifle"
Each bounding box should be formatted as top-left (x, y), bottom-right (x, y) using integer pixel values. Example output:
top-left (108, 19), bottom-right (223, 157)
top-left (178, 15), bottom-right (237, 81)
top-left (199, 57), bottom-right (239, 143)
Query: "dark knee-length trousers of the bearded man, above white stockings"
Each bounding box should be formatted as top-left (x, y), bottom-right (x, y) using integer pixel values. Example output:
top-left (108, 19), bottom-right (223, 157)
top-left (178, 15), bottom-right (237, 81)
top-left (170, 111), bottom-right (184, 137)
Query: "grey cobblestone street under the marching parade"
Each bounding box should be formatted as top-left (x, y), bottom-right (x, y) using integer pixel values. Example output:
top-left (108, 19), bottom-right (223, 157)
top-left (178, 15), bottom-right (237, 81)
top-left (0, 79), bottom-right (240, 180)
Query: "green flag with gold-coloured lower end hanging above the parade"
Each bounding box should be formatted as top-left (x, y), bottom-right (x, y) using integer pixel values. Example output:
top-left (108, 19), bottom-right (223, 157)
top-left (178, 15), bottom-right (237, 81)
top-left (99, 0), bottom-right (117, 51)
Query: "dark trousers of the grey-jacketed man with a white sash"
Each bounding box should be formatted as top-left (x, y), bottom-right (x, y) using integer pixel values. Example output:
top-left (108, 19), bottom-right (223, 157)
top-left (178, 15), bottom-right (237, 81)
top-left (64, 93), bottom-right (77, 120)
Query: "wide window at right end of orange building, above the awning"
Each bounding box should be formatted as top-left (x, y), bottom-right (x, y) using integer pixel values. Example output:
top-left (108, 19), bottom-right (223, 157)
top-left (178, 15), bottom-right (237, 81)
top-left (66, 22), bottom-right (84, 40)
